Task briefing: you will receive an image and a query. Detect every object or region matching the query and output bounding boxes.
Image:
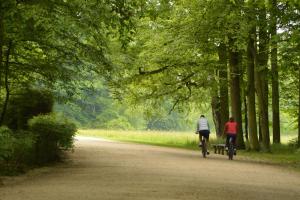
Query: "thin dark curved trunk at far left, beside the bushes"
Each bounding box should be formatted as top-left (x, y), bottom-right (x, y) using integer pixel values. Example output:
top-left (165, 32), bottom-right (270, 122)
top-left (0, 41), bottom-right (12, 126)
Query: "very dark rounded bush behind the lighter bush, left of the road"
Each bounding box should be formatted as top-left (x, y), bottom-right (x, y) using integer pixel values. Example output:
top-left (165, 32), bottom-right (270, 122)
top-left (4, 89), bottom-right (54, 130)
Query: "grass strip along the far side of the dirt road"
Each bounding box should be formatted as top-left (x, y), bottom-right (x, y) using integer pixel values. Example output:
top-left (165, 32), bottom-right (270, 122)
top-left (78, 130), bottom-right (300, 171)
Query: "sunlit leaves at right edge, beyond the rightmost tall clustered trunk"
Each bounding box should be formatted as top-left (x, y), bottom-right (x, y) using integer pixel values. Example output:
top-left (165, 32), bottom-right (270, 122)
top-left (278, 1), bottom-right (300, 145)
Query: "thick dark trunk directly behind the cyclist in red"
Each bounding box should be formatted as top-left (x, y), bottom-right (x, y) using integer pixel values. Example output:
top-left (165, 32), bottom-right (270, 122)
top-left (229, 41), bottom-right (245, 149)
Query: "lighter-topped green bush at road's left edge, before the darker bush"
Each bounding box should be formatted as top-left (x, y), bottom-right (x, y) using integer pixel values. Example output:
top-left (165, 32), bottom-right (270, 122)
top-left (28, 115), bottom-right (76, 164)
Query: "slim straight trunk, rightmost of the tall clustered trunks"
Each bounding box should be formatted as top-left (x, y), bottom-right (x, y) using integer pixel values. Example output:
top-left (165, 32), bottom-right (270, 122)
top-left (270, 0), bottom-right (280, 143)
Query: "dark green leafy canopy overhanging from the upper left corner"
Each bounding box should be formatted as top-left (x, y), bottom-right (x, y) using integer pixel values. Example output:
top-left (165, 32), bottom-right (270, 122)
top-left (0, 0), bottom-right (143, 121)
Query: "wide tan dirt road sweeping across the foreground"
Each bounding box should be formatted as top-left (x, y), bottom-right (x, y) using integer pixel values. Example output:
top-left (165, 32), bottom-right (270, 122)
top-left (0, 138), bottom-right (300, 200)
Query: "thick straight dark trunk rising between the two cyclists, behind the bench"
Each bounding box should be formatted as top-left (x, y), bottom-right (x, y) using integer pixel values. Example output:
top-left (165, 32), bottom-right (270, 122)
top-left (218, 43), bottom-right (229, 134)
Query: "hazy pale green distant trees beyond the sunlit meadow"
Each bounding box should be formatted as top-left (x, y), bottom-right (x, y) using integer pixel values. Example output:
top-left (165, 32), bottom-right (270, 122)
top-left (55, 80), bottom-right (199, 130)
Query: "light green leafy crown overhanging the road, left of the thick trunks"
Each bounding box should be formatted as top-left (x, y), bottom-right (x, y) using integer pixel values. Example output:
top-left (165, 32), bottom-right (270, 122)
top-left (108, 1), bottom-right (223, 109)
